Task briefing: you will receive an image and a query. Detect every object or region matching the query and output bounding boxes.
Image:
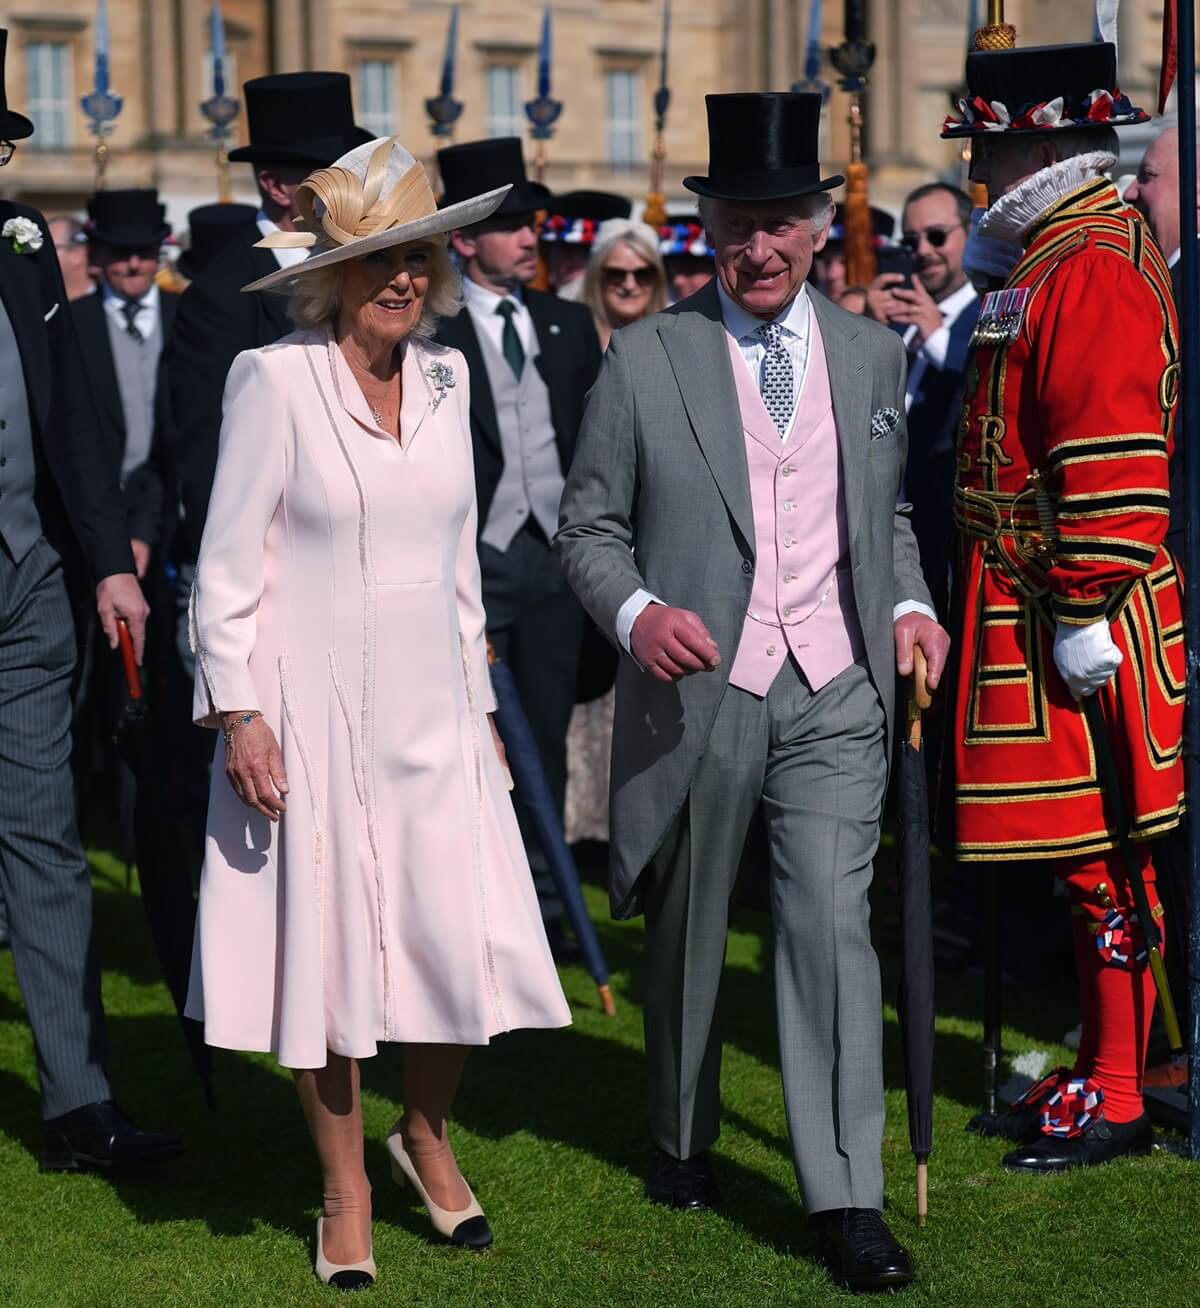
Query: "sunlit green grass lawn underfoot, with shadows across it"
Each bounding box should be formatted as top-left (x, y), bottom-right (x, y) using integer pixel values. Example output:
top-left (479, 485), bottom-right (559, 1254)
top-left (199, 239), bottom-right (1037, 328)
top-left (0, 859), bottom-right (1200, 1308)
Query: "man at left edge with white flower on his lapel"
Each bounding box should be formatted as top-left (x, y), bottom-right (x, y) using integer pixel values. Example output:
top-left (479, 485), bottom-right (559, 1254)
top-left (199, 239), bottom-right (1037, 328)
top-left (0, 30), bottom-right (181, 1171)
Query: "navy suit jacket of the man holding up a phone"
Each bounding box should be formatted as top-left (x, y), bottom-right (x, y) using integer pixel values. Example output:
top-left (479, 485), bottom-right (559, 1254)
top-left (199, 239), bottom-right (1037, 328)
top-left (904, 298), bottom-right (980, 623)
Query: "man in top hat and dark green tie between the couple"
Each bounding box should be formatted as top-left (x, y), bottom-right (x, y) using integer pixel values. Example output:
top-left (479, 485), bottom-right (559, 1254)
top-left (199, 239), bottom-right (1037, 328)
top-left (437, 136), bottom-right (599, 957)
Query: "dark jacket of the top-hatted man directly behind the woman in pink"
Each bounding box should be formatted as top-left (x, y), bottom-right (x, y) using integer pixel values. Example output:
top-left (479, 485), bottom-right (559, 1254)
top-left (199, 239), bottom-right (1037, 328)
top-left (162, 222), bottom-right (293, 560)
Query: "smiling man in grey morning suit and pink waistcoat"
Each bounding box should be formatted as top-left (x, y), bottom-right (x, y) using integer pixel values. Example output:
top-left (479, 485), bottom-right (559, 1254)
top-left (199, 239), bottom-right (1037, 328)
top-left (556, 94), bottom-right (949, 1288)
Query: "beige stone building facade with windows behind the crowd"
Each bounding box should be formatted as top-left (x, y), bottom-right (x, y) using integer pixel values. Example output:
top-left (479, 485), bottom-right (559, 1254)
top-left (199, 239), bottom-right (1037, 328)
top-left (0, 0), bottom-right (1177, 225)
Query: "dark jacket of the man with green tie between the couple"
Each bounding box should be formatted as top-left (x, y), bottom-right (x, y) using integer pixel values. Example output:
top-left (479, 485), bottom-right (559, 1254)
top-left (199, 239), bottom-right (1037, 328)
top-left (437, 290), bottom-right (601, 531)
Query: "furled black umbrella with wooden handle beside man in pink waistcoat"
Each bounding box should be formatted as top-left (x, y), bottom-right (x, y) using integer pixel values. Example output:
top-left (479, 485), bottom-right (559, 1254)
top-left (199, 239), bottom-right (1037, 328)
top-left (896, 647), bottom-right (933, 1226)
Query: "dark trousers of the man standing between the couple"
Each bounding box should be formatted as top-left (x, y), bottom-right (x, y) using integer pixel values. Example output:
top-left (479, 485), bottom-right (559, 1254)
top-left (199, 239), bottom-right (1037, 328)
top-left (479, 525), bottom-right (584, 926)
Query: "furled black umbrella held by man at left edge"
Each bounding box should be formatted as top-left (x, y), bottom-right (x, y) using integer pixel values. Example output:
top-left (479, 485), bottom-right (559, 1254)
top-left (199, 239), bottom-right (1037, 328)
top-left (115, 623), bottom-right (215, 1108)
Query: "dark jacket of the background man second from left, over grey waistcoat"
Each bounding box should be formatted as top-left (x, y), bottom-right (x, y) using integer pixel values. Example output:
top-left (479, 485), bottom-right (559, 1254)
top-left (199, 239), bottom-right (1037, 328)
top-left (71, 290), bottom-right (179, 545)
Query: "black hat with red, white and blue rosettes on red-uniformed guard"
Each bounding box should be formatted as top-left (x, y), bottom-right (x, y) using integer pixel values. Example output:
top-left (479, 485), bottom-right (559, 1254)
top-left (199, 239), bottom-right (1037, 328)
top-left (942, 41), bottom-right (1150, 140)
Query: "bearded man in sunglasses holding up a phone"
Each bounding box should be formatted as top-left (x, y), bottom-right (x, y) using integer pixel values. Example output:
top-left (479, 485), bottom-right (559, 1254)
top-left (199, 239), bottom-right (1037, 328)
top-left (866, 182), bottom-right (979, 621)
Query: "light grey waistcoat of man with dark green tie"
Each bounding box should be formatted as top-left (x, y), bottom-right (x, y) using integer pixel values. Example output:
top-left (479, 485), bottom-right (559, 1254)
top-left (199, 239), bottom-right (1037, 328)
top-left (478, 332), bottom-right (563, 553)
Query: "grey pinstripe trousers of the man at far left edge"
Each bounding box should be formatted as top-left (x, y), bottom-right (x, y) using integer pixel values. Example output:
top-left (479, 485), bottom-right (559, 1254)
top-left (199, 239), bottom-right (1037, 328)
top-left (0, 539), bottom-right (113, 1118)
